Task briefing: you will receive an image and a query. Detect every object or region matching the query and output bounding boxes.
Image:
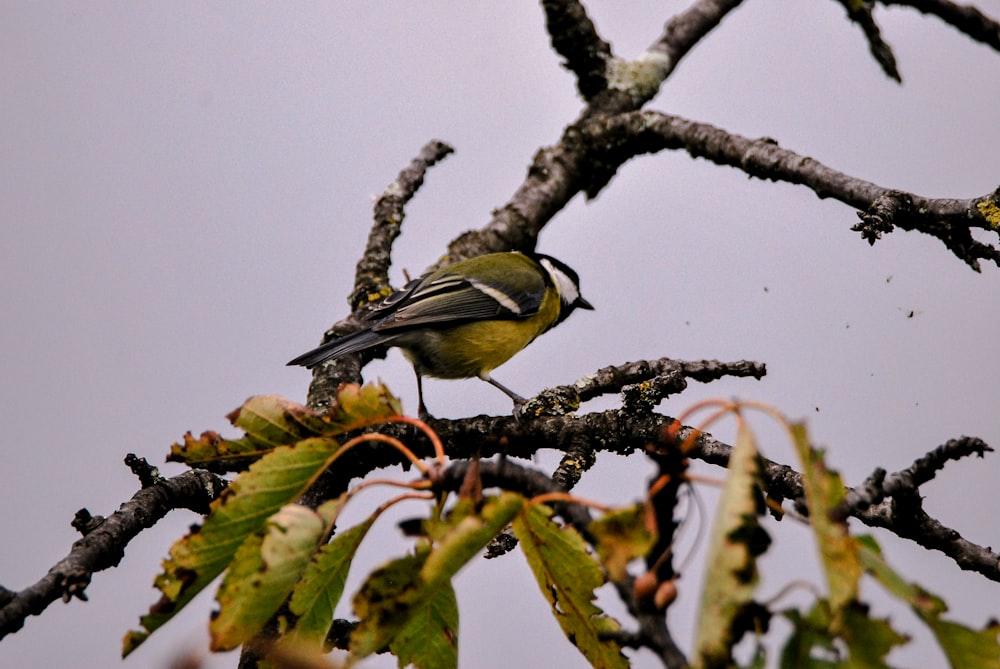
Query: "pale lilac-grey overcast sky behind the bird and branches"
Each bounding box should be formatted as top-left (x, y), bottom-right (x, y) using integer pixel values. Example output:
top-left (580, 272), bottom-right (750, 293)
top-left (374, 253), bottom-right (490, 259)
top-left (0, 0), bottom-right (1000, 667)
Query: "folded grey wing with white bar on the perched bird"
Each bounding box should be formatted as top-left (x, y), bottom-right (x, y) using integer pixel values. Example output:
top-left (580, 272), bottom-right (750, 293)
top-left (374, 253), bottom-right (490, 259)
top-left (373, 268), bottom-right (545, 332)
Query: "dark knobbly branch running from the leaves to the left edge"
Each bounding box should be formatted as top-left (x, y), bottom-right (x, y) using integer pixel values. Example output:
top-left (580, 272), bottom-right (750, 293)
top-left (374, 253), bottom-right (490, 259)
top-left (0, 456), bottom-right (227, 639)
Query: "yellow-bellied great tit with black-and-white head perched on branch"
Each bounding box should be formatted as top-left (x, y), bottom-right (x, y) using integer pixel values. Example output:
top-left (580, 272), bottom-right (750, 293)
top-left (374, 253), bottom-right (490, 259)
top-left (288, 251), bottom-right (594, 416)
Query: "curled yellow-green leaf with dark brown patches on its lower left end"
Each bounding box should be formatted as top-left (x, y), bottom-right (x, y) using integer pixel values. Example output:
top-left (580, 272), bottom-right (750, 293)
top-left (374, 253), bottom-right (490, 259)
top-left (351, 493), bottom-right (524, 658)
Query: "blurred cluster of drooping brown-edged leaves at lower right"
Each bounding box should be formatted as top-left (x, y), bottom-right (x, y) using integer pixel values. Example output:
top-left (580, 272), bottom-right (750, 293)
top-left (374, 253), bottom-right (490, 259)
top-left (692, 418), bottom-right (1000, 669)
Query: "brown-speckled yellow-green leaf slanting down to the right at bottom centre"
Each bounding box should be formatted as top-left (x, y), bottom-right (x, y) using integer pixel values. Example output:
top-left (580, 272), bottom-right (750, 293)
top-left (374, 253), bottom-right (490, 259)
top-left (513, 504), bottom-right (629, 668)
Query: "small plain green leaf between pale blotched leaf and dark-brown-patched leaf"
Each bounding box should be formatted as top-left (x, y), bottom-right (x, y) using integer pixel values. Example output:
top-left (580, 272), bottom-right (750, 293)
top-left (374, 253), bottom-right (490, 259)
top-left (289, 508), bottom-right (375, 647)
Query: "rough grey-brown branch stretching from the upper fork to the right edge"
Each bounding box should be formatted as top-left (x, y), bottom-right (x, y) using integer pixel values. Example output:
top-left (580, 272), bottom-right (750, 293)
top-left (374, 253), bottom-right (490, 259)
top-left (583, 111), bottom-right (1000, 271)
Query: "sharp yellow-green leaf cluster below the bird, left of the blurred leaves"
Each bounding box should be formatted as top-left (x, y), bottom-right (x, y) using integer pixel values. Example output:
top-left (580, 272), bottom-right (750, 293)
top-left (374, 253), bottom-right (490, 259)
top-left (124, 385), bottom-right (640, 667)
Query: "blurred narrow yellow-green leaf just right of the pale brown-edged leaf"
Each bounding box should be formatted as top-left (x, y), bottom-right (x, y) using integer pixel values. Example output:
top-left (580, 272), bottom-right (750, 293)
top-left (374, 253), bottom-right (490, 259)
top-left (791, 423), bottom-right (862, 612)
